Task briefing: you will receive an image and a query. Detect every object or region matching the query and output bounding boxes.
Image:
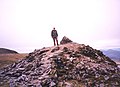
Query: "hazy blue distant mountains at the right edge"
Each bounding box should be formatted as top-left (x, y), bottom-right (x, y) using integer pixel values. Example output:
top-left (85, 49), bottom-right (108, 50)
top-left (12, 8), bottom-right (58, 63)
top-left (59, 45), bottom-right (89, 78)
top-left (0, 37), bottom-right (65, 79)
top-left (102, 49), bottom-right (120, 61)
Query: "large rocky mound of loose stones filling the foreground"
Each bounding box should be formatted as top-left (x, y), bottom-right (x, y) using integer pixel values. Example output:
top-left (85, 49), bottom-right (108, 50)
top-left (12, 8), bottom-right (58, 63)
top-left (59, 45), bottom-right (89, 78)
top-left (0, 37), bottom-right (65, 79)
top-left (0, 38), bottom-right (120, 87)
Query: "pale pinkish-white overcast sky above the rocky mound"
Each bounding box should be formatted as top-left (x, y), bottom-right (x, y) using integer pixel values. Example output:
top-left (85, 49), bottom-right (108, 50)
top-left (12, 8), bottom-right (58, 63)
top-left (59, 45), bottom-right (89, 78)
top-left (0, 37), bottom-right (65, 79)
top-left (0, 0), bottom-right (120, 53)
